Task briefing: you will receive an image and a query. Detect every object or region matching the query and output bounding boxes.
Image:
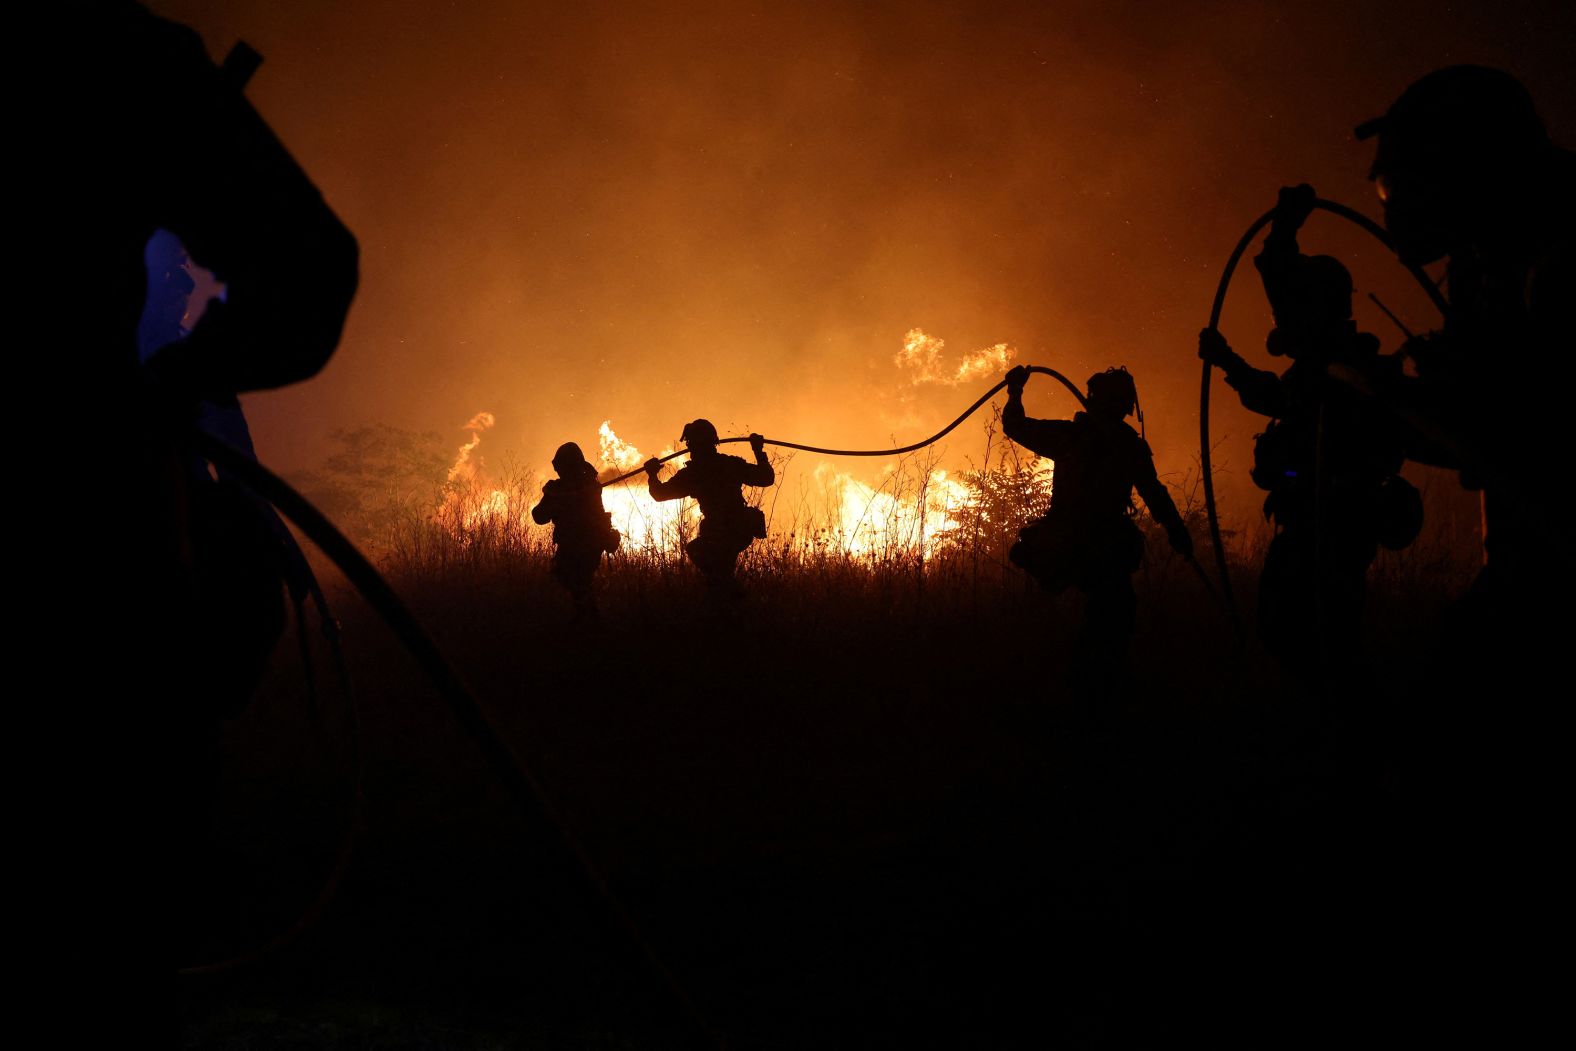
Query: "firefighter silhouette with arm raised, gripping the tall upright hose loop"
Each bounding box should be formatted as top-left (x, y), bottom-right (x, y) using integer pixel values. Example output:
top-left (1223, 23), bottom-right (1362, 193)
top-left (1198, 186), bottom-right (1423, 681)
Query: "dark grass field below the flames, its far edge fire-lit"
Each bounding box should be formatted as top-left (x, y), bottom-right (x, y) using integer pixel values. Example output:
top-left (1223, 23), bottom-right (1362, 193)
top-left (181, 447), bottom-right (1474, 1048)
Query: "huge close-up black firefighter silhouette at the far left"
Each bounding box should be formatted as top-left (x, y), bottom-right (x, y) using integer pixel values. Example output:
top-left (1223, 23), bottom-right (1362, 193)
top-left (46, 3), bottom-right (358, 995)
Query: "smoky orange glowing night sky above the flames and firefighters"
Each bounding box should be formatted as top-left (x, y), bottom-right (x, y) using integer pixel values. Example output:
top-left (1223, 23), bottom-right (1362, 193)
top-left (151, 0), bottom-right (1576, 516)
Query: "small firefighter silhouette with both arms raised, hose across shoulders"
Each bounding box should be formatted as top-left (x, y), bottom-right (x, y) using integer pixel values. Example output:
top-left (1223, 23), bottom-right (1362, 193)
top-left (646, 419), bottom-right (777, 591)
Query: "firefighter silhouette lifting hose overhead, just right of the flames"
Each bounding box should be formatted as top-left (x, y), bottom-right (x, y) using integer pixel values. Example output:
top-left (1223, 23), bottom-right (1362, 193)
top-left (1001, 366), bottom-right (1193, 690)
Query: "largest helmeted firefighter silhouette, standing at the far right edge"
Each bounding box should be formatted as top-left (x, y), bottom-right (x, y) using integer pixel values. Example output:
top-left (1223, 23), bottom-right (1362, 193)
top-left (1357, 66), bottom-right (1576, 1043)
